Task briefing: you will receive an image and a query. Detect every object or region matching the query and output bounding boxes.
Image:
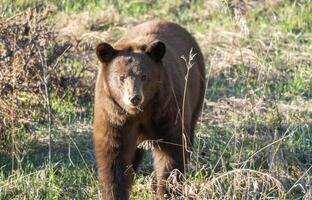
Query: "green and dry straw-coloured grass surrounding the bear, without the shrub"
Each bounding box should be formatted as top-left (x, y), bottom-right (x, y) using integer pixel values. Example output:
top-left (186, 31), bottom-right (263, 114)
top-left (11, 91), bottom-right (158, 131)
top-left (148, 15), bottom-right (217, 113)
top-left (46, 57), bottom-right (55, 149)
top-left (0, 0), bottom-right (312, 199)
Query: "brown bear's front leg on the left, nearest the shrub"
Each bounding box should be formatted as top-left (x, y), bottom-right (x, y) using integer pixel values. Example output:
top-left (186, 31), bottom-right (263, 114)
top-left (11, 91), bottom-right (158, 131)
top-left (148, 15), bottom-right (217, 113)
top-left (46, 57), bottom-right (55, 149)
top-left (93, 124), bottom-right (136, 200)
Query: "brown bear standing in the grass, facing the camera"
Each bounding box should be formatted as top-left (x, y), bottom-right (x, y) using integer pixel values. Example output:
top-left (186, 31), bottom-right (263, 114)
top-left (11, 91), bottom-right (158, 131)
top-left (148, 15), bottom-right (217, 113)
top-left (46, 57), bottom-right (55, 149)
top-left (93, 20), bottom-right (206, 200)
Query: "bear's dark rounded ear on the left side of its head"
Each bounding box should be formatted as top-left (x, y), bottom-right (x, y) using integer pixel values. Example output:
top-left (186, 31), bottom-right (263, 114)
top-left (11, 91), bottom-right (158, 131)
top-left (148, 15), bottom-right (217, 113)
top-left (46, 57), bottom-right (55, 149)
top-left (96, 42), bottom-right (118, 63)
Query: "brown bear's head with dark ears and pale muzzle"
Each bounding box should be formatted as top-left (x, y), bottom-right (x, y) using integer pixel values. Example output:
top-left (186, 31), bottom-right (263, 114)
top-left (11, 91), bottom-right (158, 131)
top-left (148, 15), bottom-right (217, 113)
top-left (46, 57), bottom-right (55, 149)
top-left (96, 40), bottom-right (166, 114)
